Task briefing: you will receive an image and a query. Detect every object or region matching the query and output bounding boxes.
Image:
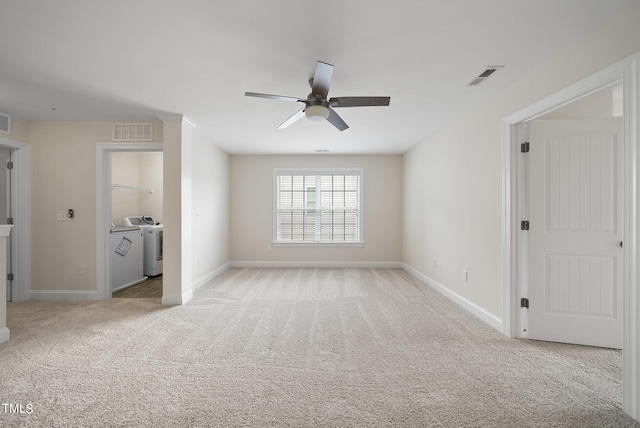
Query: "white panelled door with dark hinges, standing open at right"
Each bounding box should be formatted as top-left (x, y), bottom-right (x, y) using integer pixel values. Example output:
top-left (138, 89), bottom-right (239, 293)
top-left (523, 118), bottom-right (622, 348)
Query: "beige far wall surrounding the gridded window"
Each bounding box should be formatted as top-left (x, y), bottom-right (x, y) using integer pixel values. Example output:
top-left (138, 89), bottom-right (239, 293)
top-left (231, 155), bottom-right (402, 262)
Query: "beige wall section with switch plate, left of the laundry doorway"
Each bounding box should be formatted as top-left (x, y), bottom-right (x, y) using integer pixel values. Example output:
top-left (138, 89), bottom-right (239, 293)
top-left (28, 122), bottom-right (162, 291)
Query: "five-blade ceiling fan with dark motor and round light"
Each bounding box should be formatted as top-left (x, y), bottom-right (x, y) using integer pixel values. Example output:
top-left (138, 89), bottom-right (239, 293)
top-left (244, 61), bottom-right (391, 131)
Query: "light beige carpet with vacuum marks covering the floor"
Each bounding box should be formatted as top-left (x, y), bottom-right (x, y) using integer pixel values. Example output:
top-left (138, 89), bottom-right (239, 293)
top-left (0, 269), bottom-right (640, 427)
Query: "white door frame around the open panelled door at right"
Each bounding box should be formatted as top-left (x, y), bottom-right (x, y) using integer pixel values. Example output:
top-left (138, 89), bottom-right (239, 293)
top-left (502, 53), bottom-right (640, 420)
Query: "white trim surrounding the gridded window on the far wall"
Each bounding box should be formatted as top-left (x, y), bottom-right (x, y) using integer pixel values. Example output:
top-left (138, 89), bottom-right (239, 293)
top-left (271, 168), bottom-right (366, 247)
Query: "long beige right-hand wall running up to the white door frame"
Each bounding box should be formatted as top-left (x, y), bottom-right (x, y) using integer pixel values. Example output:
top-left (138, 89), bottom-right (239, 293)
top-left (403, 5), bottom-right (640, 317)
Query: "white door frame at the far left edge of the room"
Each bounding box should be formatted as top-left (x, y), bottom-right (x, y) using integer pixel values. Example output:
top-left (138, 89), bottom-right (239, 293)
top-left (0, 137), bottom-right (31, 302)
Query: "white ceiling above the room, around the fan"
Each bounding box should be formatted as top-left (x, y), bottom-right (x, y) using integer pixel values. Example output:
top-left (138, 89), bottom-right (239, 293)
top-left (0, 0), bottom-right (637, 154)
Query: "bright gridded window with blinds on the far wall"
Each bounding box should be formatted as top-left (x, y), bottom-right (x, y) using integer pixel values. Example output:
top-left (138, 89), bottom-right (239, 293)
top-left (274, 169), bottom-right (362, 243)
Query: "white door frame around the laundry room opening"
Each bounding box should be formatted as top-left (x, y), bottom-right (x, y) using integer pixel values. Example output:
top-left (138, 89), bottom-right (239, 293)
top-left (96, 142), bottom-right (163, 299)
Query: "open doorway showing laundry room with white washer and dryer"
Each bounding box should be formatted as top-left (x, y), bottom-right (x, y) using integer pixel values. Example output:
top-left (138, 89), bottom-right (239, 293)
top-left (96, 143), bottom-right (164, 299)
